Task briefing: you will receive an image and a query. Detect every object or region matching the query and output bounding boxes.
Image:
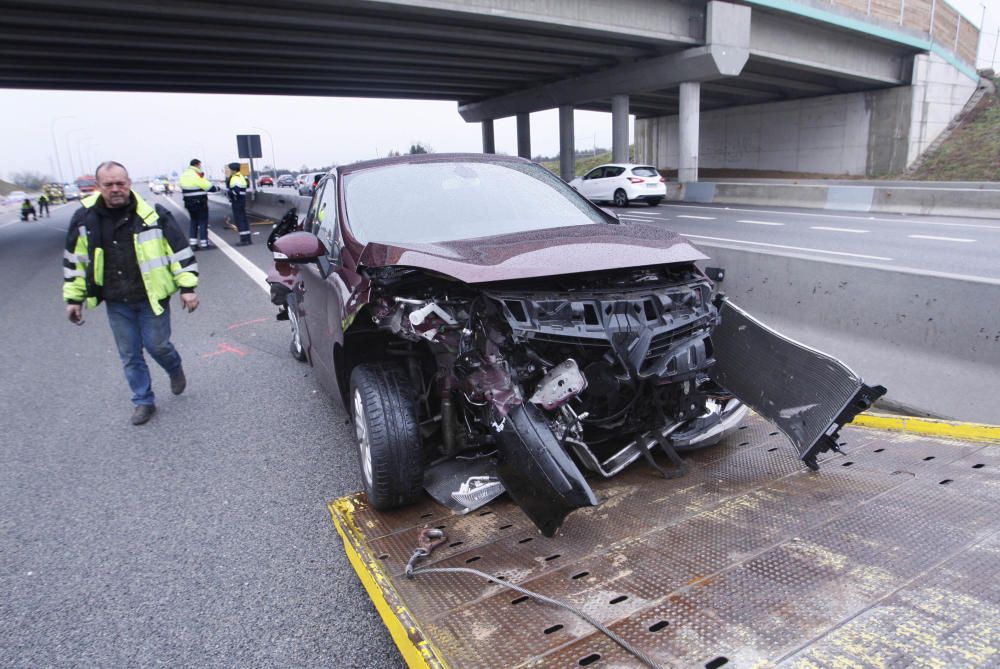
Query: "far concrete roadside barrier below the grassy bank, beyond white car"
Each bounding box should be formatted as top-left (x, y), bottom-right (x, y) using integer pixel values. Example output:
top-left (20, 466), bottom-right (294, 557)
top-left (667, 180), bottom-right (1000, 218)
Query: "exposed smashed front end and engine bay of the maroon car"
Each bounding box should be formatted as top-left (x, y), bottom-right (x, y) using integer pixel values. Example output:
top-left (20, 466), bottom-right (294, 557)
top-left (369, 264), bottom-right (746, 534)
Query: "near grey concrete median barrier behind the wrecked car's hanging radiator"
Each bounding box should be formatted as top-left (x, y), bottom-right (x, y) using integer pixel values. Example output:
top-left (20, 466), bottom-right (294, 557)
top-left (698, 243), bottom-right (1000, 424)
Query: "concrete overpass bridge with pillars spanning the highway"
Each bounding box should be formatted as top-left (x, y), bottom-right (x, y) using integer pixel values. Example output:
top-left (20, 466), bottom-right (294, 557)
top-left (0, 0), bottom-right (978, 181)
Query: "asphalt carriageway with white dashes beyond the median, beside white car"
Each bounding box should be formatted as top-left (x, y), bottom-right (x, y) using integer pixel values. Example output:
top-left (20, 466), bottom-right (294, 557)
top-left (614, 202), bottom-right (1000, 279)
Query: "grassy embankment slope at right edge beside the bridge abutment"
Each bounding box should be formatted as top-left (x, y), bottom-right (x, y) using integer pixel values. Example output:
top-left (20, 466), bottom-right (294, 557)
top-left (910, 78), bottom-right (1000, 181)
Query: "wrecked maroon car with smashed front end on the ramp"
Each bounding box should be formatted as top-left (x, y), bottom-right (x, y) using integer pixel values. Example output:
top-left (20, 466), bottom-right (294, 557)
top-left (268, 154), bottom-right (884, 536)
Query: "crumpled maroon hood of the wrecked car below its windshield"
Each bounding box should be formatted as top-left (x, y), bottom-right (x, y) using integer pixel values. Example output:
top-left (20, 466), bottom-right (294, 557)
top-left (359, 224), bottom-right (708, 283)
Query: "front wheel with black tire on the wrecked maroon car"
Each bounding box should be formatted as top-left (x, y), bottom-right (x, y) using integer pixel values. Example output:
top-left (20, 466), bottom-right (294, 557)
top-left (350, 364), bottom-right (424, 509)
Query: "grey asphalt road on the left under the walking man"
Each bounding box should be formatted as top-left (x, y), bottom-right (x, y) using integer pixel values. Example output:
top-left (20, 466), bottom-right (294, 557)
top-left (0, 187), bottom-right (404, 667)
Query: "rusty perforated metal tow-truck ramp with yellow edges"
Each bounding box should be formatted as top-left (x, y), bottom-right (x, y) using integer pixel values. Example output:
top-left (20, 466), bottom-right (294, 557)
top-left (330, 417), bottom-right (1000, 669)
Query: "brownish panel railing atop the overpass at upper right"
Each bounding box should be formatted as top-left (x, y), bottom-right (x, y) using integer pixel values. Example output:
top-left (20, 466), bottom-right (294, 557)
top-left (829, 0), bottom-right (979, 66)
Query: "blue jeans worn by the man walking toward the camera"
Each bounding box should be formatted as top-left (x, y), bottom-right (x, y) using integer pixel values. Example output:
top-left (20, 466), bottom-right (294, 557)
top-left (107, 300), bottom-right (181, 405)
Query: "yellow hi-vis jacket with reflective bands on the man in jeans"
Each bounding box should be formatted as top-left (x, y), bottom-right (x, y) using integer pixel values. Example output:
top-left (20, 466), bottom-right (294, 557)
top-left (63, 191), bottom-right (198, 316)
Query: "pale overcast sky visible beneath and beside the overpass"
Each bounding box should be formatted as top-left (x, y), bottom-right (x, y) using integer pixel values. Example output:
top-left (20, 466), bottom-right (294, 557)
top-left (0, 0), bottom-right (1000, 180)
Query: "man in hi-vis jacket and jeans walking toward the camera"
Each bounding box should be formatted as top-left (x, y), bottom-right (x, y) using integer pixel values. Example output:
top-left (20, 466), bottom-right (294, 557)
top-left (63, 161), bottom-right (198, 425)
